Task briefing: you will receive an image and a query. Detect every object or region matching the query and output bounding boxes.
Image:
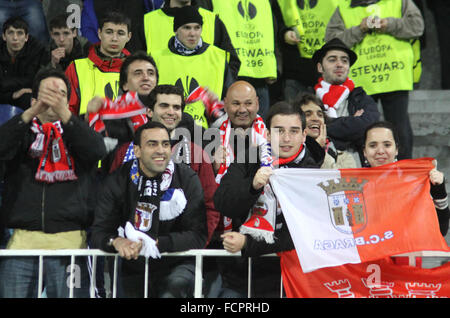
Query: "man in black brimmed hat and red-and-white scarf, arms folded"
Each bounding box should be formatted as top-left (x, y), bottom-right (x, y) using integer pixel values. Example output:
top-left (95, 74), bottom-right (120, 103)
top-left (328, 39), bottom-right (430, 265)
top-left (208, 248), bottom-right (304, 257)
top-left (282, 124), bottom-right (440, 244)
top-left (313, 38), bottom-right (380, 166)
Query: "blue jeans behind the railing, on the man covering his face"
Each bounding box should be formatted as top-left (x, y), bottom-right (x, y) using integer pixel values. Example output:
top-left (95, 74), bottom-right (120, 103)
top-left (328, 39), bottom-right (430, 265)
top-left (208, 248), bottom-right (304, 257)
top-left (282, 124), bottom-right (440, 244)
top-left (0, 256), bottom-right (89, 298)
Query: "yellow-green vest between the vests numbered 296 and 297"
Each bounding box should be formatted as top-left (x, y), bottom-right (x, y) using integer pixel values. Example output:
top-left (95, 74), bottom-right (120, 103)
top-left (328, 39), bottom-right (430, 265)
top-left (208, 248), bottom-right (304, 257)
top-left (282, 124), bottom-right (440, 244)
top-left (278, 0), bottom-right (338, 59)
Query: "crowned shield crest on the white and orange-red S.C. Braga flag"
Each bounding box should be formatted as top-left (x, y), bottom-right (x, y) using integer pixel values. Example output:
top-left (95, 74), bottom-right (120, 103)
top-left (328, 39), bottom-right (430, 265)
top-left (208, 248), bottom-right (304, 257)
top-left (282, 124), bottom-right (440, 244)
top-left (317, 178), bottom-right (368, 234)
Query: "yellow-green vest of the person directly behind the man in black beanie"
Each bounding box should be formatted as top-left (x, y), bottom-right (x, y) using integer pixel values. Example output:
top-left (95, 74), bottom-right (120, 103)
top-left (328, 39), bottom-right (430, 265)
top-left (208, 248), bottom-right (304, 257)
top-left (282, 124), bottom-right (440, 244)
top-left (144, 8), bottom-right (216, 55)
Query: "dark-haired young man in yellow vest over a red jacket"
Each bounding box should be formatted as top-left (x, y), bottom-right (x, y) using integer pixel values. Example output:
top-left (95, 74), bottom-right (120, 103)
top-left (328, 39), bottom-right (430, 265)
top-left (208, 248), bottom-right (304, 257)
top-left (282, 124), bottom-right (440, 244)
top-left (66, 11), bottom-right (131, 115)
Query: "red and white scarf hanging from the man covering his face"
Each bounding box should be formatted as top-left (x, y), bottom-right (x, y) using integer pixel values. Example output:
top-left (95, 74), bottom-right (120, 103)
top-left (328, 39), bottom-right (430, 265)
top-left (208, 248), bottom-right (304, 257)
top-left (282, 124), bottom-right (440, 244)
top-left (29, 117), bottom-right (77, 183)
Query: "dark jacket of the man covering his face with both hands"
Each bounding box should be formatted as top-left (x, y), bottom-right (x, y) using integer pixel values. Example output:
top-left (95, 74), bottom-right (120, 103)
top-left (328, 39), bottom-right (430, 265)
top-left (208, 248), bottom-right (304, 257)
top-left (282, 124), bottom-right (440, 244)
top-left (0, 115), bottom-right (106, 233)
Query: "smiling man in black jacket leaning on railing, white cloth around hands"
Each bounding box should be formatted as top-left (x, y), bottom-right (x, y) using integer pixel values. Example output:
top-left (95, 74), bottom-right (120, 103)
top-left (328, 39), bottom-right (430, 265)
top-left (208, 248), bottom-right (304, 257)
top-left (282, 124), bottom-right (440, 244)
top-left (92, 122), bottom-right (207, 297)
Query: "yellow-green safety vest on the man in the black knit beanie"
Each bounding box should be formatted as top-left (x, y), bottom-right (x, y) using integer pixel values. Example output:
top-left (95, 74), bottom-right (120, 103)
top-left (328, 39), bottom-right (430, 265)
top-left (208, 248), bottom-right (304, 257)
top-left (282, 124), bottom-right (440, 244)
top-left (153, 45), bottom-right (228, 129)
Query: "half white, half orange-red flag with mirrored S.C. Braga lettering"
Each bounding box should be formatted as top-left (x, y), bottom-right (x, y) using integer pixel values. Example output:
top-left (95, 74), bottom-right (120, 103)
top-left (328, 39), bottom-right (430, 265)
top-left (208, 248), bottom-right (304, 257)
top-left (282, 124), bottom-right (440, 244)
top-left (270, 158), bottom-right (449, 273)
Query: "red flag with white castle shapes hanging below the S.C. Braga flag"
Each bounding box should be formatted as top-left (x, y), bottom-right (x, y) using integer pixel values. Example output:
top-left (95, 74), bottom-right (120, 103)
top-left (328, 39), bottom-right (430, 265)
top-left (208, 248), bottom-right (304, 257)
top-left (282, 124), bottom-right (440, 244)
top-left (280, 250), bottom-right (450, 298)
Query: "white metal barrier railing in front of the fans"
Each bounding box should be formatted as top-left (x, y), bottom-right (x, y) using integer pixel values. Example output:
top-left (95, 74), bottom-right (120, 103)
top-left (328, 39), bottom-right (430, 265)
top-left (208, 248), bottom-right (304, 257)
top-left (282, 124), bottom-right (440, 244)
top-left (0, 249), bottom-right (450, 298)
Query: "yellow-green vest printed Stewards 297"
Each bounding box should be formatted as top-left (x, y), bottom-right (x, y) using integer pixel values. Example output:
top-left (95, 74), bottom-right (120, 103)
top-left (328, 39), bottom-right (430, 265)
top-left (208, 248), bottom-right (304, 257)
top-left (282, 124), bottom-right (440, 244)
top-left (339, 0), bottom-right (414, 95)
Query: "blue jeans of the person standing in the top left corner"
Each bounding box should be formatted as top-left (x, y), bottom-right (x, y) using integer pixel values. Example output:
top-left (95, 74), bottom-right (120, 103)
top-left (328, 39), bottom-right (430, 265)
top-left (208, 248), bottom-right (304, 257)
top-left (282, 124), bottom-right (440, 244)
top-left (0, 0), bottom-right (50, 46)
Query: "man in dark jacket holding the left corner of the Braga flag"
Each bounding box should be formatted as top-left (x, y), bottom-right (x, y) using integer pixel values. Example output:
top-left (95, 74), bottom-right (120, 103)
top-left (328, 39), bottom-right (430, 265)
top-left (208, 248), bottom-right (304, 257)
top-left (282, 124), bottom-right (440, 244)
top-left (214, 102), bottom-right (325, 297)
